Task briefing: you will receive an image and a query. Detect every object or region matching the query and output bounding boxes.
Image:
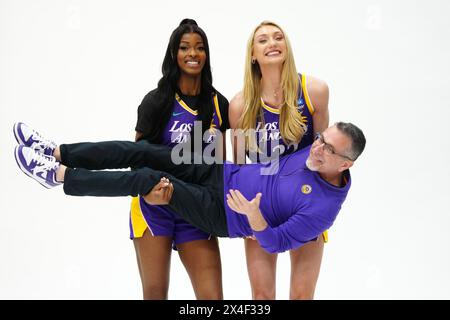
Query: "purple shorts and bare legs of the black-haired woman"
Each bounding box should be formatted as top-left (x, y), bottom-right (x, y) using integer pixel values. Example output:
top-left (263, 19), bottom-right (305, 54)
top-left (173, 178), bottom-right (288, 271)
top-left (130, 197), bottom-right (222, 300)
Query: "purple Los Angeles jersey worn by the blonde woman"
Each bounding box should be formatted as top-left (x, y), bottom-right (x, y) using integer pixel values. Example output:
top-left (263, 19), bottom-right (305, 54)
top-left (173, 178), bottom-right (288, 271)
top-left (248, 75), bottom-right (314, 162)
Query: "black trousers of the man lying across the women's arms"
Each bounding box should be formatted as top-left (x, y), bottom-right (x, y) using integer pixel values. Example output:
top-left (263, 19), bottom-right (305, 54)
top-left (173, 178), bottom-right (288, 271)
top-left (60, 141), bottom-right (228, 237)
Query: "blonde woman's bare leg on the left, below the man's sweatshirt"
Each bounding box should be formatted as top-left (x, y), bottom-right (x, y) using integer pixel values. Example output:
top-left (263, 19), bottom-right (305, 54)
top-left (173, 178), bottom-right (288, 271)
top-left (244, 239), bottom-right (278, 300)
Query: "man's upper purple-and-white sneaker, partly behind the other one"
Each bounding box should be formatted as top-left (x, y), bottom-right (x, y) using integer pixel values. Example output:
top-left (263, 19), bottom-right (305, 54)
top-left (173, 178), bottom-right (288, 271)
top-left (13, 122), bottom-right (57, 156)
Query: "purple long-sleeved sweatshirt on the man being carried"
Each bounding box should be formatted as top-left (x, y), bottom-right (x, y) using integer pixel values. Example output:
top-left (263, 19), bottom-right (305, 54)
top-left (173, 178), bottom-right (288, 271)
top-left (224, 146), bottom-right (350, 252)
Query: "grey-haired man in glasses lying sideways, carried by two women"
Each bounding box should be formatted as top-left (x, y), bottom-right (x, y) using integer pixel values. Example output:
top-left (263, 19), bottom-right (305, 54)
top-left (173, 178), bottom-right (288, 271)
top-left (14, 122), bottom-right (366, 252)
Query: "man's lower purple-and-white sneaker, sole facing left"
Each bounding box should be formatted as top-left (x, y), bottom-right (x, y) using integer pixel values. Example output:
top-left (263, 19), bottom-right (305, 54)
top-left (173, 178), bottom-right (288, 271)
top-left (14, 145), bottom-right (61, 189)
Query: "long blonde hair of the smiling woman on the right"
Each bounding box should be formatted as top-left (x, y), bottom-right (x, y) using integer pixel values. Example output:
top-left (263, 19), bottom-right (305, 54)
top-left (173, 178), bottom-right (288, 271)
top-left (239, 21), bottom-right (306, 150)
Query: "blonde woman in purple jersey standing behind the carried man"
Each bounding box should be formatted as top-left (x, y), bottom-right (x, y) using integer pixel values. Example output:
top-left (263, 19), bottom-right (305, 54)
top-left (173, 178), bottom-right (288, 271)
top-left (229, 21), bottom-right (329, 299)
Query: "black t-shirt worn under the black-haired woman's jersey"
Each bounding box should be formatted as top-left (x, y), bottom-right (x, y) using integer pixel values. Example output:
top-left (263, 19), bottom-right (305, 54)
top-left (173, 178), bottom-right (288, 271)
top-left (135, 89), bottom-right (230, 139)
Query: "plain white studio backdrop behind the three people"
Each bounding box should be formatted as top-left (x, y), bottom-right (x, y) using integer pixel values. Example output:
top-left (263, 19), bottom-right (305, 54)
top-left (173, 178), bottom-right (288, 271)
top-left (0, 0), bottom-right (450, 299)
